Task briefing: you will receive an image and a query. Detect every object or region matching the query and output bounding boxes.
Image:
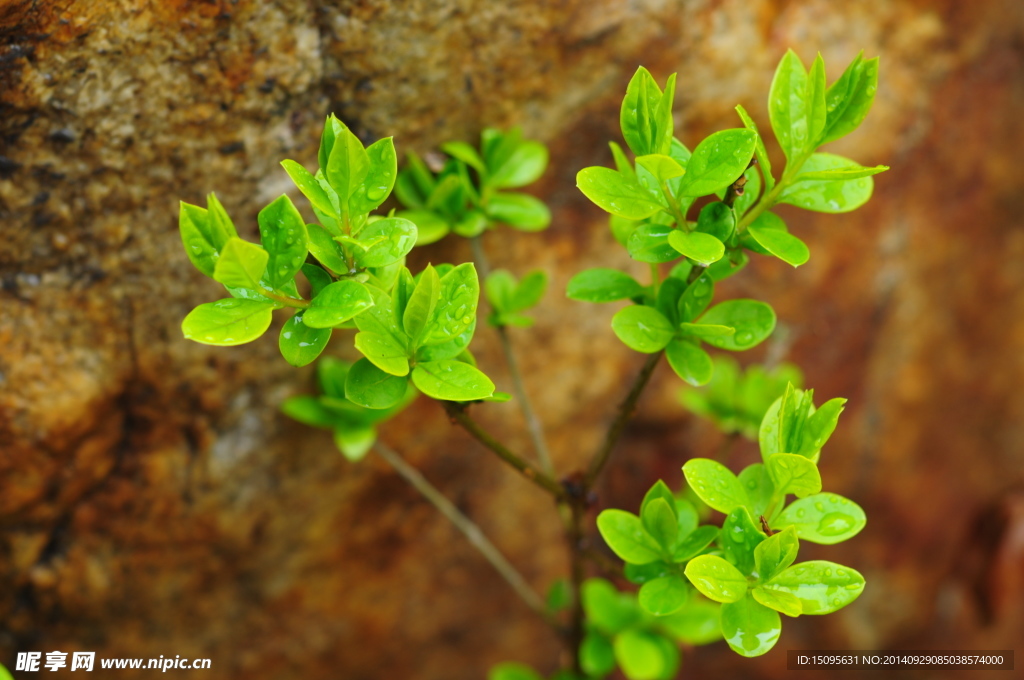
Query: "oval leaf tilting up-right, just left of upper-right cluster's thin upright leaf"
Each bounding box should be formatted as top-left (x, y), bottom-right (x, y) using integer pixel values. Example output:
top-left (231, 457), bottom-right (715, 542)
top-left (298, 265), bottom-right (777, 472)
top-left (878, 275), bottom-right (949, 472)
top-left (678, 128), bottom-right (758, 196)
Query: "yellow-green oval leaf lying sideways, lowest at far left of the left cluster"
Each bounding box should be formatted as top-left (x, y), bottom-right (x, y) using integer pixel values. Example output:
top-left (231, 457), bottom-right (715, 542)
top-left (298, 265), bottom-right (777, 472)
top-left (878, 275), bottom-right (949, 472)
top-left (181, 298), bottom-right (281, 347)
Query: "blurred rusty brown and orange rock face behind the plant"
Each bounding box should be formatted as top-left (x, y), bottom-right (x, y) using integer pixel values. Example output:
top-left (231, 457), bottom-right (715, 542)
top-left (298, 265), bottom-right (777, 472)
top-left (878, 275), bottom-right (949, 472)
top-left (0, 0), bottom-right (1024, 680)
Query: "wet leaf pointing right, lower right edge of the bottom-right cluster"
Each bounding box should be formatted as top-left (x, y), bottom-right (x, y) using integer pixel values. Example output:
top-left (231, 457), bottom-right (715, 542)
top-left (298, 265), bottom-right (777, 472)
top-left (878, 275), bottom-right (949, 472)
top-left (763, 560), bottom-right (864, 614)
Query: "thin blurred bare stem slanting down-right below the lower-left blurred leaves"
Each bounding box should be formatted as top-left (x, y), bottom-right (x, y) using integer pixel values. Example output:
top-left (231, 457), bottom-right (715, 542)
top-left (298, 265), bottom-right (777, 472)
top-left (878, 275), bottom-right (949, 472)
top-left (374, 441), bottom-right (551, 623)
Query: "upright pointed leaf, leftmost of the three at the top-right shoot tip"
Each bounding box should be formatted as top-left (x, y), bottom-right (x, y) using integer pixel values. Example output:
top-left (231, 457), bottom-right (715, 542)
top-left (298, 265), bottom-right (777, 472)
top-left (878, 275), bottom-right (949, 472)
top-left (768, 49), bottom-right (811, 163)
